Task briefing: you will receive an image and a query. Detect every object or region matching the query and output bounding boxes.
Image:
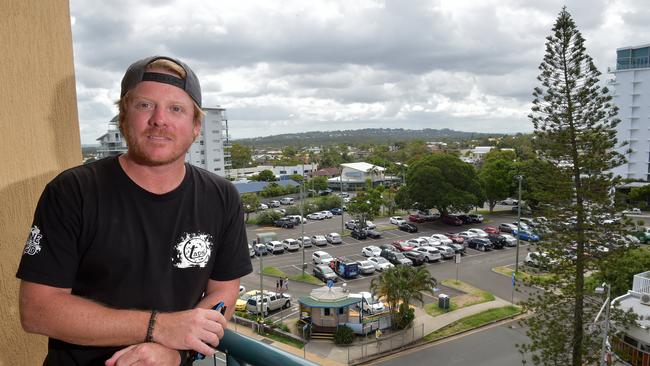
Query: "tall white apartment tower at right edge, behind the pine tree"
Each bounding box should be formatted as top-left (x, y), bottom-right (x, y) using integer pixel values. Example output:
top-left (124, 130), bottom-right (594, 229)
top-left (610, 44), bottom-right (650, 180)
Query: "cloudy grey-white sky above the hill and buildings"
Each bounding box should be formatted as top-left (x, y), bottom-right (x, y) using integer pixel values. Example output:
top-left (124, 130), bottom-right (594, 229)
top-left (70, 0), bottom-right (650, 144)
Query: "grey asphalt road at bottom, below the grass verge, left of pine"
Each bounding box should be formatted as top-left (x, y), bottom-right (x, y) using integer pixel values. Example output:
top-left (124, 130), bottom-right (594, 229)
top-left (369, 321), bottom-right (531, 366)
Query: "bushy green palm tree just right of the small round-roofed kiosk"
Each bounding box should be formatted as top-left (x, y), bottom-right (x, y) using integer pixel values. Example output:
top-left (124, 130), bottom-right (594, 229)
top-left (370, 266), bottom-right (438, 324)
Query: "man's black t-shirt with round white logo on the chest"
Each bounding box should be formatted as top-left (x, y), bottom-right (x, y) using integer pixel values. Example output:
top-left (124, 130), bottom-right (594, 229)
top-left (16, 157), bottom-right (252, 365)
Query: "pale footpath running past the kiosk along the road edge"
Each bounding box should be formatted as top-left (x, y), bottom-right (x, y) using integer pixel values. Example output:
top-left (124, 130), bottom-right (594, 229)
top-left (194, 298), bottom-right (511, 366)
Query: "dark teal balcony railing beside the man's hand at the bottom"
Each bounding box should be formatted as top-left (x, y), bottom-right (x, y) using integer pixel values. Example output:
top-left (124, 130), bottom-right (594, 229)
top-left (217, 329), bottom-right (316, 366)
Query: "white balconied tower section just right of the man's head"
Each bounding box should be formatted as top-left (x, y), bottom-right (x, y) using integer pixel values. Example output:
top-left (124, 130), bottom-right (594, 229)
top-left (185, 108), bottom-right (231, 177)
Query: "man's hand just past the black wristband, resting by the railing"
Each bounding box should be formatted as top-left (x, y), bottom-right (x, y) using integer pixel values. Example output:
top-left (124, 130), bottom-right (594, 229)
top-left (153, 308), bottom-right (227, 356)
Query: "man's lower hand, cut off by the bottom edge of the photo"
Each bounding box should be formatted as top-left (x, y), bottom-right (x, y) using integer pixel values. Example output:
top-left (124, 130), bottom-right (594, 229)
top-left (104, 343), bottom-right (181, 366)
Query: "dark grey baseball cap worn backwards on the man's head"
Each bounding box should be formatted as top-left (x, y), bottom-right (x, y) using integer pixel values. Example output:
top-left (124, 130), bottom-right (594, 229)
top-left (120, 56), bottom-right (201, 107)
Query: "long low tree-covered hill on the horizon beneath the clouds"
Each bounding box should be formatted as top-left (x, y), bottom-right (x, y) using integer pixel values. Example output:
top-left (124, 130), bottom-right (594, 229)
top-left (234, 128), bottom-right (503, 147)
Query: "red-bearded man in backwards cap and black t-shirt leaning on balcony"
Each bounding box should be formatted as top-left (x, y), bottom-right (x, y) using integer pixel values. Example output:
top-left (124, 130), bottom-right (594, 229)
top-left (17, 57), bottom-right (252, 366)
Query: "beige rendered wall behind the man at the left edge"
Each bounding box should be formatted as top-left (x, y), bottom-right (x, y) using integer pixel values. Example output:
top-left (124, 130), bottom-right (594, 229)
top-left (0, 0), bottom-right (81, 366)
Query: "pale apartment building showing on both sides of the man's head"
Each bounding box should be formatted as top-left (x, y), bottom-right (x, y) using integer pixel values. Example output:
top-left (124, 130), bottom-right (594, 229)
top-left (97, 108), bottom-right (231, 177)
